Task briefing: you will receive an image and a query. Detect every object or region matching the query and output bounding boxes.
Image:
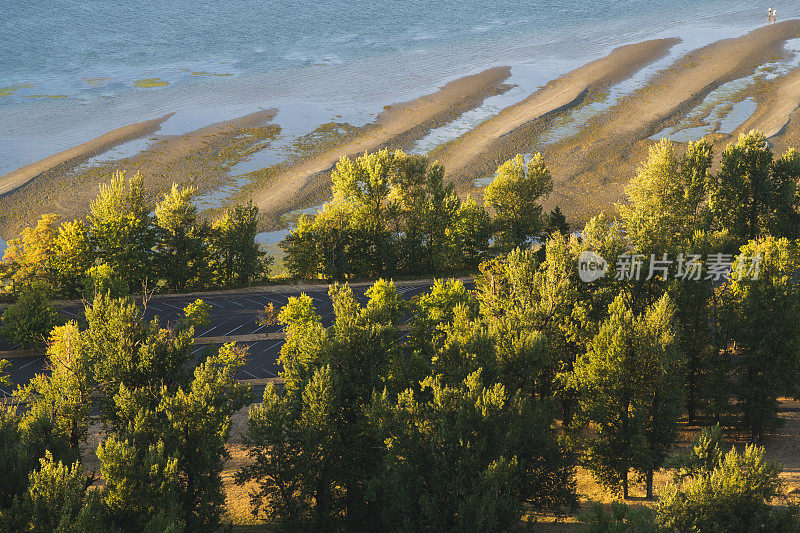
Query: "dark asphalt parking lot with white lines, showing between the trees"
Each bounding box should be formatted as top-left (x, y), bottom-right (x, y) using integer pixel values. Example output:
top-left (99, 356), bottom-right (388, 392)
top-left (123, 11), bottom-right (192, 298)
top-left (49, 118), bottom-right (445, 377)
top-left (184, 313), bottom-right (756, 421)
top-left (0, 283), bottom-right (444, 396)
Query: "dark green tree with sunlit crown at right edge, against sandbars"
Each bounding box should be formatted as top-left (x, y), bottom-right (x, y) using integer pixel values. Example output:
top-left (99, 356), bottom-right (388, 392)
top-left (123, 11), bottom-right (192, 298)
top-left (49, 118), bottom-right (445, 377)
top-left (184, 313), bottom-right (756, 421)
top-left (709, 131), bottom-right (800, 243)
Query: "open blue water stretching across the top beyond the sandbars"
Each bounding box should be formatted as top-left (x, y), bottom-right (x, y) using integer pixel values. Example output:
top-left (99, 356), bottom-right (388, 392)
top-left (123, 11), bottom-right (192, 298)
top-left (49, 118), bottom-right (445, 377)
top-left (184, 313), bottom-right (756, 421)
top-left (0, 0), bottom-right (798, 174)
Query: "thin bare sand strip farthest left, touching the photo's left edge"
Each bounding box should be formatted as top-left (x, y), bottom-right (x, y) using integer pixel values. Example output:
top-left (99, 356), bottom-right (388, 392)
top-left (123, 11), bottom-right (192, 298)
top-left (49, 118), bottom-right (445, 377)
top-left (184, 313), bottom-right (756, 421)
top-left (0, 113), bottom-right (174, 195)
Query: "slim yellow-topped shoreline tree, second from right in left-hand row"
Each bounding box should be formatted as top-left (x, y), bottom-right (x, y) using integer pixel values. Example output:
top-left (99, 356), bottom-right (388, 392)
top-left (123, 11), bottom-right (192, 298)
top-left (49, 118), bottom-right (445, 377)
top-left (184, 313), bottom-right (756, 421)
top-left (155, 183), bottom-right (208, 292)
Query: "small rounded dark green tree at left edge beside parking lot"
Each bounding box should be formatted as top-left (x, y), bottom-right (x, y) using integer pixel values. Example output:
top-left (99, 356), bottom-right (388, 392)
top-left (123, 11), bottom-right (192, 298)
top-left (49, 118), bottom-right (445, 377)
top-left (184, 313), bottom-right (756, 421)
top-left (0, 281), bottom-right (60, 347)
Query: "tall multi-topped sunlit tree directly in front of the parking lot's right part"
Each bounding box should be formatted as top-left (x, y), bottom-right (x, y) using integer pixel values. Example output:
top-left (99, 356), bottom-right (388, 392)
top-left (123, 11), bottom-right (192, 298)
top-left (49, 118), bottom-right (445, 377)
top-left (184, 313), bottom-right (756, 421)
top-left (237, 281), bottom-right (402, 530)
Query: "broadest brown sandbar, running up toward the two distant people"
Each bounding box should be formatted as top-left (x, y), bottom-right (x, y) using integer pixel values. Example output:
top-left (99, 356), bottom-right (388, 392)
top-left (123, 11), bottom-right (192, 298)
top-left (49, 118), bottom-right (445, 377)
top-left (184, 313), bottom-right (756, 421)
top-left (494, 20), bottom-right (800, 222)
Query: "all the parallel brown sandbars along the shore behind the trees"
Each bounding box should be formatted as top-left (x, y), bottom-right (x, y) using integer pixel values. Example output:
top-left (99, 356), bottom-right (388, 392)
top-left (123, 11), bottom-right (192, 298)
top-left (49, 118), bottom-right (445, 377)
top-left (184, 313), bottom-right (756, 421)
top-left (0, 20), bottom-right (800, 238)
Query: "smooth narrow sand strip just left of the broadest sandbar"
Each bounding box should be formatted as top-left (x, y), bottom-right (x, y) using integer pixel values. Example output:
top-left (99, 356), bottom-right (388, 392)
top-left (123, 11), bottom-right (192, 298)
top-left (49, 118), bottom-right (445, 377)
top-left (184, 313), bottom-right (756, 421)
top-left (432, 38), bottom-right (679, 178)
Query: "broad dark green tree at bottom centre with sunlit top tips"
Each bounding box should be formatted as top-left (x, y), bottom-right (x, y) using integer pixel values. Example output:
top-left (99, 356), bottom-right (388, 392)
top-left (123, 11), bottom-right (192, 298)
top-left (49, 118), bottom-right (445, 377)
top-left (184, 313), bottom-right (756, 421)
top-left (369, 369), bottom-right (574, 531)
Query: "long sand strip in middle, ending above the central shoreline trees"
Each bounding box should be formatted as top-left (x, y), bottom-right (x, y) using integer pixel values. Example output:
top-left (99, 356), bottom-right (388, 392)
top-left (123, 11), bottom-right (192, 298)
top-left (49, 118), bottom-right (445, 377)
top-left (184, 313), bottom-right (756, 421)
top-left (253, 67), bottom-right (511, 218)
